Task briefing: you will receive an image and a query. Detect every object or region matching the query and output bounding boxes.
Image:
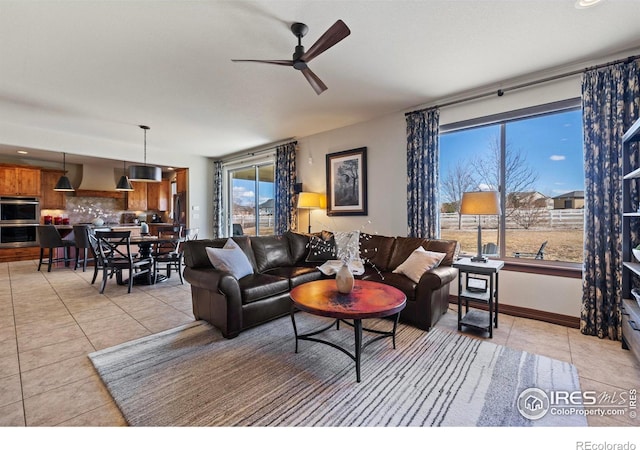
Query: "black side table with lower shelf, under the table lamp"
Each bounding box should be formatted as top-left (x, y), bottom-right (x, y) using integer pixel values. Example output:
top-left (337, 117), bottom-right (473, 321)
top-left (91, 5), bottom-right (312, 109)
top-left (453, 258), bottom-right (504, 338)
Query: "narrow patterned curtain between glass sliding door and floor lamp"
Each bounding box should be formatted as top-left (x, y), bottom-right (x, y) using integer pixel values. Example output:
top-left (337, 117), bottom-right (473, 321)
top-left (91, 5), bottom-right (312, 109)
top-left (274, 142), bottom-right (297, 235)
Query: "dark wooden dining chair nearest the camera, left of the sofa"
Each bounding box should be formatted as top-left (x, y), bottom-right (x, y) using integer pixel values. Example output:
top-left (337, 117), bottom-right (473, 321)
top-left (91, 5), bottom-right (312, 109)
top-left (96, 231), bottom-right (153, 294)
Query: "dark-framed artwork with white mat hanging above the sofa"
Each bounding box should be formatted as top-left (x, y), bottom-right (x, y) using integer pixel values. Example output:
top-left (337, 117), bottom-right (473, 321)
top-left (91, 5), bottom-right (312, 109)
top-left (326, 147), bottom-right (368, 216)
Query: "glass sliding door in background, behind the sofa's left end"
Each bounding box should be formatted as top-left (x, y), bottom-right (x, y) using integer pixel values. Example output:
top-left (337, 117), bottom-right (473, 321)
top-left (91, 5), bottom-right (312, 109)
top-left (223, 157), bottom-right (275, 236)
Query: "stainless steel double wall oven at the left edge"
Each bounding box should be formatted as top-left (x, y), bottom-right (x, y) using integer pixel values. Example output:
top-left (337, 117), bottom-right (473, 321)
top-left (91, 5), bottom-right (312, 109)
top-left (0, 197), bottom-right (40, 248)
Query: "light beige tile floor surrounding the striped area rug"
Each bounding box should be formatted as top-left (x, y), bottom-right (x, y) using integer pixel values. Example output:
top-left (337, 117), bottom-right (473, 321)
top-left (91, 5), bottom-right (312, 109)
top-left (0, 261), bottom-right (640, 427)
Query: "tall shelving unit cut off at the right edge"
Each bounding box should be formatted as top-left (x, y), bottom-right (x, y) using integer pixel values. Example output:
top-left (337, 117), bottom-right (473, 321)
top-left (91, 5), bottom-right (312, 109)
top-left (621, 119), bottom-right (640, 361)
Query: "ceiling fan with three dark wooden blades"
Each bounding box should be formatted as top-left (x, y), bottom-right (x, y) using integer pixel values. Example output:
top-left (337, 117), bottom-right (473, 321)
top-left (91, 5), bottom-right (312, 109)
top-left (231, 20), bottom-right (351, 95)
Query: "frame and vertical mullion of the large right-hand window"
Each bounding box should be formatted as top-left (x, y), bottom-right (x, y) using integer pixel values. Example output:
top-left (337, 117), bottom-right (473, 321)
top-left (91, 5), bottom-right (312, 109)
top-left (439, 97), bottom-right (583, 278)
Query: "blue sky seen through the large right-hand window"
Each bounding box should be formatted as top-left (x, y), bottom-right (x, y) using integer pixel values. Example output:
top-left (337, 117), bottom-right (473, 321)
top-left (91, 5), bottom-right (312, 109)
top-left (440, 110), bottom-right (584, 197)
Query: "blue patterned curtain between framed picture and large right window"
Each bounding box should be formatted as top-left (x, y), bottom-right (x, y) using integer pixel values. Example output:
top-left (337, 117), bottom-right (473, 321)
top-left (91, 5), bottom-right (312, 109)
top-left (406, 108), bottom-right (440, 238)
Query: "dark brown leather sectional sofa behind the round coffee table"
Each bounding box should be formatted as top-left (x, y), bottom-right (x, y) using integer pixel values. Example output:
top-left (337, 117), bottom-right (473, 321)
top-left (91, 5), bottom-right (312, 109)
top-left (184, 232), bottom-right (457, 338)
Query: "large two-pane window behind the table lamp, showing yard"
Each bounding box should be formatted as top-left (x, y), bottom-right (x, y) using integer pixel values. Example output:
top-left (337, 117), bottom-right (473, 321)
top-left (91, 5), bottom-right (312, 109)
top-left (440, 101), bottom-right (584, 263)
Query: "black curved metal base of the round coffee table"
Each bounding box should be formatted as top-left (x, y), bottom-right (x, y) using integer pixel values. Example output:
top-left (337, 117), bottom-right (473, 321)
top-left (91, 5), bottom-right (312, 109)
top-left (291, 308), bottom-right (400, 383)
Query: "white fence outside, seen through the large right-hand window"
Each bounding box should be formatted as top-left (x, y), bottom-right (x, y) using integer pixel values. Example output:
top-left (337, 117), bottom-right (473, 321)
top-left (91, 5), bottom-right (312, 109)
top-left (440, 209), bottom-right (584, 230)
